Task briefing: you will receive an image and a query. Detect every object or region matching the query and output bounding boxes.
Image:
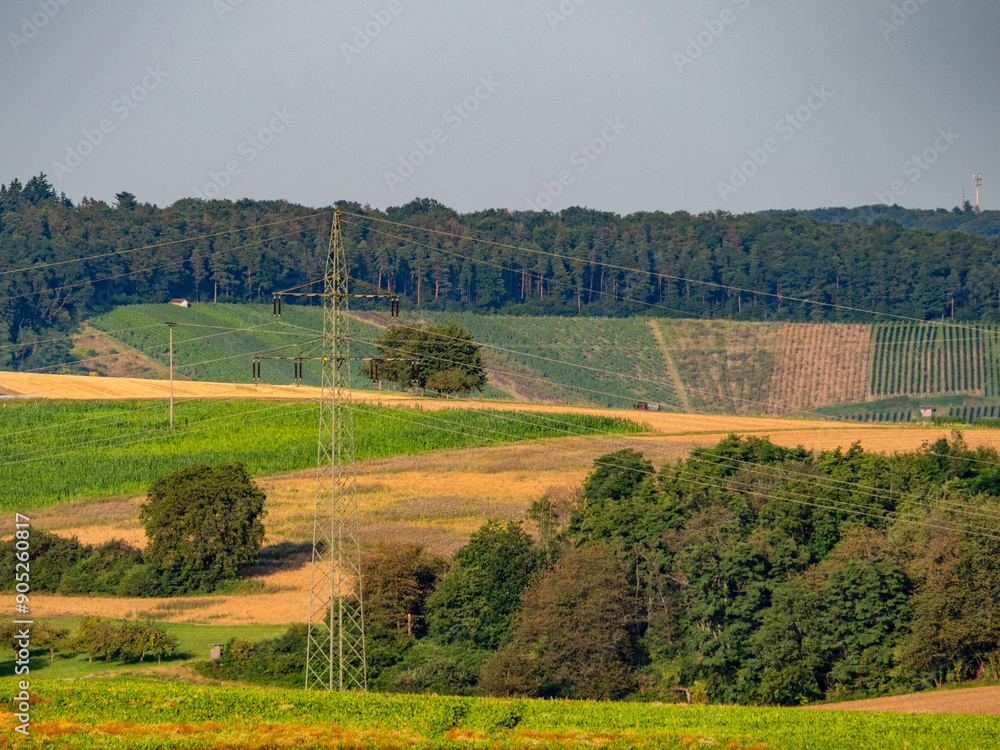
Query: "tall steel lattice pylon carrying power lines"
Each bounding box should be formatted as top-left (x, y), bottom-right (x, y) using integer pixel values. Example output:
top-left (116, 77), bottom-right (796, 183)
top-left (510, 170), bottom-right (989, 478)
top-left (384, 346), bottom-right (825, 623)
top-left (253, 211), bottom-right (399, 691)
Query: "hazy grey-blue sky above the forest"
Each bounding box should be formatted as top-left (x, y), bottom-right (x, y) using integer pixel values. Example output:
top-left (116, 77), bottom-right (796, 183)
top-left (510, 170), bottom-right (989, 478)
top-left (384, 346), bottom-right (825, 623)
top-left (0, 0), bottom-right (1000, 214)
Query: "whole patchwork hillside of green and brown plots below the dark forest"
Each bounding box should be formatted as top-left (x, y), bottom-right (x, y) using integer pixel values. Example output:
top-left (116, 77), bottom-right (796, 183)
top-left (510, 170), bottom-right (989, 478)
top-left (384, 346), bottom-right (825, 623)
top-left (74, 304), bottom-right (1000, 421)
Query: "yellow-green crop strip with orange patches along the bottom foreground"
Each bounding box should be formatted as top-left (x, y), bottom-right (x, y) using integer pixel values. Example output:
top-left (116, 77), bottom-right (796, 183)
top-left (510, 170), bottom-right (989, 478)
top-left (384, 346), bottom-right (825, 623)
top-left (0, 678), bottom-right (1000, 750)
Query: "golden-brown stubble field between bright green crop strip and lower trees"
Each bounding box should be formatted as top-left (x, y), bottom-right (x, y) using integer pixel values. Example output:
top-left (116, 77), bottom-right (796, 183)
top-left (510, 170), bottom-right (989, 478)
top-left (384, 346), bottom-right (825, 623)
top-left (21, 438), bottom-right (696, 624)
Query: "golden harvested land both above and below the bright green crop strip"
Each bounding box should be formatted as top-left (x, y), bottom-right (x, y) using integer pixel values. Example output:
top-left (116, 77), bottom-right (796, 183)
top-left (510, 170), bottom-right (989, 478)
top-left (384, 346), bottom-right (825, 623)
top-left (15, 373), bottom-right (1000, 624)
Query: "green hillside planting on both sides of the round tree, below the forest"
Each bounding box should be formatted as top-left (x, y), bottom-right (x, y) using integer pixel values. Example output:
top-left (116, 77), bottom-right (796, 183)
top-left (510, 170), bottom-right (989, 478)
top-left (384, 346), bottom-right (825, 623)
top-left (83, 304), bottom-right (676, 407)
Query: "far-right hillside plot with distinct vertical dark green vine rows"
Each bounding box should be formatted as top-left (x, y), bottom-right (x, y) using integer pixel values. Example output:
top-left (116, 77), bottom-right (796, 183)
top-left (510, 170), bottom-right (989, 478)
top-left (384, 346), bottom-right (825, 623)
top-left (869, 323), bottom-right (1000, 398)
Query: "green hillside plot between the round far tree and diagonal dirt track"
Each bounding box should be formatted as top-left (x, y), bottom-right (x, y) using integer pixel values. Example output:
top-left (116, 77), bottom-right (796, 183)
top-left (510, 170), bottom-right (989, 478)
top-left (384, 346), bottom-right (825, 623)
top-left (418, 313), bottom-right (679, 408)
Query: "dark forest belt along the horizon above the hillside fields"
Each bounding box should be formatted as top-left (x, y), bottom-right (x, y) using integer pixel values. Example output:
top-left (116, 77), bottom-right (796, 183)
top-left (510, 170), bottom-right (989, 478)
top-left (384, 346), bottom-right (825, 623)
top-left (0, 175), bottom-right (1000, 369)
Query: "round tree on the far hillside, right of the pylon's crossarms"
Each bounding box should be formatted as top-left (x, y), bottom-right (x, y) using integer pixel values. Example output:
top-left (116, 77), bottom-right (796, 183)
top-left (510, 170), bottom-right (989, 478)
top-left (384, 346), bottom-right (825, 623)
top-left (369, 322), bottom-right (487, 393)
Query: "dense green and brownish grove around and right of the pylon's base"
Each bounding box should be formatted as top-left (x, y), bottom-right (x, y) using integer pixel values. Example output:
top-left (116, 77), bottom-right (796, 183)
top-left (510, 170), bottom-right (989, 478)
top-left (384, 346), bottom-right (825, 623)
top-left (203, 433), bottom-right (1000, 704)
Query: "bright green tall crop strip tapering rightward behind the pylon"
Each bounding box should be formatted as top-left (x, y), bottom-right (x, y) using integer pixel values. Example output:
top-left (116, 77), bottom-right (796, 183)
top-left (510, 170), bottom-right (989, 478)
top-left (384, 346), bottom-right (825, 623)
top-left (0, 400), bottom-right (644, 512)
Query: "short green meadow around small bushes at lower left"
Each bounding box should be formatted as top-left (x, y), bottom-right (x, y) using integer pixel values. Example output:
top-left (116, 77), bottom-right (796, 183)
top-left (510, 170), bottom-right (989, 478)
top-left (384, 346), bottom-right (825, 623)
top-left (0, 620), bottom-right (288, 680)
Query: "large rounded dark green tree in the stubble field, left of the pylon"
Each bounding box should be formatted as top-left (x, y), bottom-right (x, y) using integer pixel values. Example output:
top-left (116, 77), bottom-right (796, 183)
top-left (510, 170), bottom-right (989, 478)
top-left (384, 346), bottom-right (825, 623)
top-left (140, 463), bottom-right (265, 583)
